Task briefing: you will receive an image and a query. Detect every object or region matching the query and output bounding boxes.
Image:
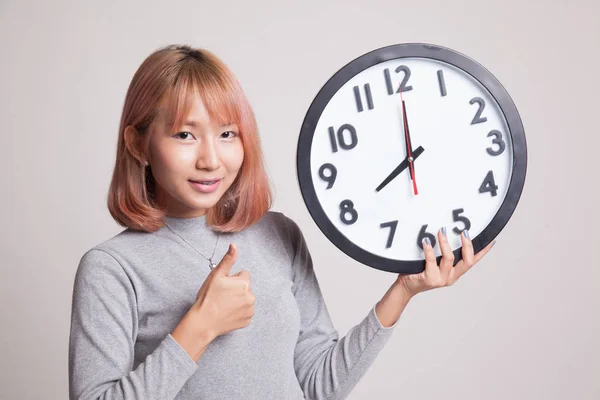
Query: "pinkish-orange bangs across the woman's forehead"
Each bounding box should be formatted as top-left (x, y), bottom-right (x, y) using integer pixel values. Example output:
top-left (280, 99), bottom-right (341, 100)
top-left (163, 63), bottom-right (241, 130)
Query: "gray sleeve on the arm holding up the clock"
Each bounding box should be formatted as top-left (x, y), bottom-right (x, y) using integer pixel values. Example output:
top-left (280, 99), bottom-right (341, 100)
top-left (285, 217), bottom-right (398, 400)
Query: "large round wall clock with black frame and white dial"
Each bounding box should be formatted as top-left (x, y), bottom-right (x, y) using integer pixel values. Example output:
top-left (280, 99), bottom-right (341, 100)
top-left (297, 43), bottom-right (527, 273)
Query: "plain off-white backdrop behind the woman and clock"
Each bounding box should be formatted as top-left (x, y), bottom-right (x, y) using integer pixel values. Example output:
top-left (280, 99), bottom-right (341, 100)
top-left (0, 0), bottom-right (600, 400)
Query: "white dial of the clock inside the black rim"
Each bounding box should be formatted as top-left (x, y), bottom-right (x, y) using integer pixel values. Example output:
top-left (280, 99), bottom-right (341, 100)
top-left (310, 57), bottom-right (513, 260)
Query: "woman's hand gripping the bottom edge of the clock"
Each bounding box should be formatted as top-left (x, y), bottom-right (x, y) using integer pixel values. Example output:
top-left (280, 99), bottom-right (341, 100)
top-left (395, 229), bottom-right (496, 296)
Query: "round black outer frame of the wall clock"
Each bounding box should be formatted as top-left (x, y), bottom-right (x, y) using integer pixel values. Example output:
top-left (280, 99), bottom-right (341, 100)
top-left (296, 43), bottom-right (527, 274)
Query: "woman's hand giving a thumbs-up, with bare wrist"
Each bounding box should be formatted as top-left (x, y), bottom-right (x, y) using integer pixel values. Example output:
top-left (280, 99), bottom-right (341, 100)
top-left (171, 244), bottom-right (256, 361)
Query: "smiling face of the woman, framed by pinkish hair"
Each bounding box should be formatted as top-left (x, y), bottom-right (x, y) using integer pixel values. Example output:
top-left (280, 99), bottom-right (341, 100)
top-left (149, 95), bottom-right (244, 218)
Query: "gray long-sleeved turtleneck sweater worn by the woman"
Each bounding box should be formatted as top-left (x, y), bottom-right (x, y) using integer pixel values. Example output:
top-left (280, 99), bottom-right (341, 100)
top-left (69, 211), bottom-right (397, 400)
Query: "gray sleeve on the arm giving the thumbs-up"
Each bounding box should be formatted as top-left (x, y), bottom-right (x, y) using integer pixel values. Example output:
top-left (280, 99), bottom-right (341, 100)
top-left (69, 249), bottom-right (198, 400)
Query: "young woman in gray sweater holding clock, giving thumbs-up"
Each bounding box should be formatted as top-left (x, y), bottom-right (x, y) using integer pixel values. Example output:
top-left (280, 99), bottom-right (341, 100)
top-left (69, 45), bottom-right (491, 400)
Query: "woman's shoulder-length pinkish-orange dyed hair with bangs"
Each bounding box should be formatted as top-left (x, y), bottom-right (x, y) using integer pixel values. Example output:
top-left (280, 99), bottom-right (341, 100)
top-left (107, 45), bottom-right (272, 232)
